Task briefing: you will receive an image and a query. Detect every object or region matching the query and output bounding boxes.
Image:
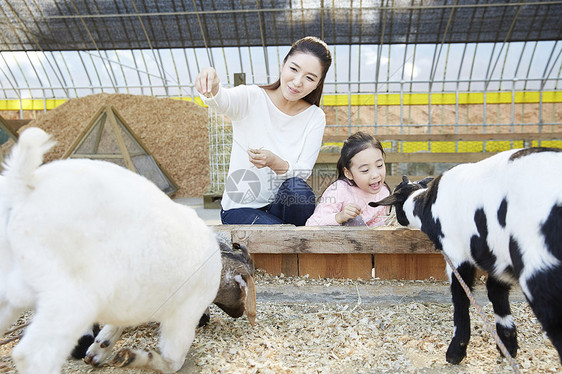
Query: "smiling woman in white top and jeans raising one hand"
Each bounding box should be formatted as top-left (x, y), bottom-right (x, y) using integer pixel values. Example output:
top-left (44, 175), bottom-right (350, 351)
top-left (195, 37), bottom-right (332, 226)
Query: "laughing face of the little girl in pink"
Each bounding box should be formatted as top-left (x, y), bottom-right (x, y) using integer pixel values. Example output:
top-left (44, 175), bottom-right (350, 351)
top-left (343, 147), bottom-right (386, 194)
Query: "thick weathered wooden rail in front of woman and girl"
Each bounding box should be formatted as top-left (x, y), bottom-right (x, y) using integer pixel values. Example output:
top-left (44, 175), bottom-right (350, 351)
top-left (214, 225), bottom-right (435, 254)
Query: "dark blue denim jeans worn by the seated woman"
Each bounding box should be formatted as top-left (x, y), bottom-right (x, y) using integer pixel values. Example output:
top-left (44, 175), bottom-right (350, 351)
top-left (221, 177), bottom-right (316, 226)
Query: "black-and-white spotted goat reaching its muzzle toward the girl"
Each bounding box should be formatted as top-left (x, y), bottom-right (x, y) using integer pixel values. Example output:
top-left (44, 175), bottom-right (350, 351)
top-left (370, 148), bottom-right (562, 364)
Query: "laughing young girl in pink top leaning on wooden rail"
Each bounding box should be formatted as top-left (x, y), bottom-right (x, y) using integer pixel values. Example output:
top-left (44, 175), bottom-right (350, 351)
top-left (306, 132), bottom-right (390, 227)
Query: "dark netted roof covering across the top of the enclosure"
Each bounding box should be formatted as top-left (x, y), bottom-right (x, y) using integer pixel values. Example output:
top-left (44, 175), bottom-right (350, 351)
top-left (0, 0), bottom-right (562, 51)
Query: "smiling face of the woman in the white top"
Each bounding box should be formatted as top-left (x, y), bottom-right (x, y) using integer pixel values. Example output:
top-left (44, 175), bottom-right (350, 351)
top-left (280, 52), bottom-right (322, 101)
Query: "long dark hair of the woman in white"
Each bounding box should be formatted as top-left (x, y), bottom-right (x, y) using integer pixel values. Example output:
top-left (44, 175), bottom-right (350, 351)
top-left (260, 36), bottom-right (332, 106)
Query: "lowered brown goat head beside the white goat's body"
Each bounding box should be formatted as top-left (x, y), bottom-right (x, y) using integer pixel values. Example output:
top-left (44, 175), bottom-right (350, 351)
top-left (214, 240), bottom-right (256, 326)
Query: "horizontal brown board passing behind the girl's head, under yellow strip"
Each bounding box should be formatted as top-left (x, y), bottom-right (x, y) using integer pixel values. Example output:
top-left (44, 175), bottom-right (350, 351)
top-left (316, 152), bottom-right (497, 164)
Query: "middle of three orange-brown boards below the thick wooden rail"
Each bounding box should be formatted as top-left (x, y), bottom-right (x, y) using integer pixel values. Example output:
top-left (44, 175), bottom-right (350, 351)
top-left (299, 254), bottom-right (373, 279)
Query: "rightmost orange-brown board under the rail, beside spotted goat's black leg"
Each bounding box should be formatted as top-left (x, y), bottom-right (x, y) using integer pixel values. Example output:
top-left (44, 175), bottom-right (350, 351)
top-left (374, 253), bottom-right (448, 280)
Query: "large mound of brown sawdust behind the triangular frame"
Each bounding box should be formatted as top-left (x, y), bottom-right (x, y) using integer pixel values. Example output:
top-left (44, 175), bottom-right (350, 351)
top-left (20, 94), bottom-right (209, 197)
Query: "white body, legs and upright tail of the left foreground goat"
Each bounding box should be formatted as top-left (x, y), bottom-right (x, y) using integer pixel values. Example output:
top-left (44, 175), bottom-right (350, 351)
top-left (0, 128), bottom-right (221, 374)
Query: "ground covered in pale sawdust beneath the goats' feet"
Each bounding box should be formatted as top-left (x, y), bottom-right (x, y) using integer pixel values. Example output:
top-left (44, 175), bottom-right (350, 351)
top-left (0, 273), bottom-right (562, 374)
